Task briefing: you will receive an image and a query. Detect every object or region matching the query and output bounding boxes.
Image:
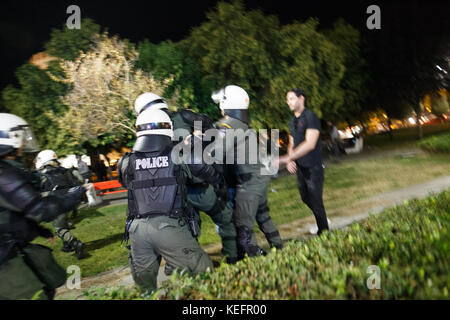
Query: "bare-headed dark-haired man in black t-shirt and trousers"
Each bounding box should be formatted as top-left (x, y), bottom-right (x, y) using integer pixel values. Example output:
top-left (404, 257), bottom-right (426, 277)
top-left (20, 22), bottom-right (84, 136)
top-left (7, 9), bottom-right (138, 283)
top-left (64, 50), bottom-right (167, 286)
top-left (279, 88), bottom-right (328, 235)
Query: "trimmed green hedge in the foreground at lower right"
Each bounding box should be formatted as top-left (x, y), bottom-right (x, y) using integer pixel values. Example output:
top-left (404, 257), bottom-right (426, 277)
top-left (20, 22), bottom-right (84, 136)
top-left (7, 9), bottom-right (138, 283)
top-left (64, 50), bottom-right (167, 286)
top-left (82, 189), bottom-right (450, 299)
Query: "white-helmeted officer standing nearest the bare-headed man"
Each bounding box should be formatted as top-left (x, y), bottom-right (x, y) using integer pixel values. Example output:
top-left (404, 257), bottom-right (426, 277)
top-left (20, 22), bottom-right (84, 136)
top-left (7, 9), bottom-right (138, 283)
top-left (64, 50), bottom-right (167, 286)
top-left (211, 85), bottom-right (283, 257)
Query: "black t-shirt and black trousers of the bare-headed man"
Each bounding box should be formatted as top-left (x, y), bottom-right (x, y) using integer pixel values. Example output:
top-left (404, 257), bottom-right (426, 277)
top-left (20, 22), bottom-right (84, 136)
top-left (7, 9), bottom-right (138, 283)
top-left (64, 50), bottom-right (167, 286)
top-left (289, 108), bottom-right (328, 234)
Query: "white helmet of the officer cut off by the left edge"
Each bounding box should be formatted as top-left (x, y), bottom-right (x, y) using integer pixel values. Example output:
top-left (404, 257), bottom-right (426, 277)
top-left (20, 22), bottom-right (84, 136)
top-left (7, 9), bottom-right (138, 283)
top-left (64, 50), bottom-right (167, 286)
top-left (0, 113), bottom-right (39, 155)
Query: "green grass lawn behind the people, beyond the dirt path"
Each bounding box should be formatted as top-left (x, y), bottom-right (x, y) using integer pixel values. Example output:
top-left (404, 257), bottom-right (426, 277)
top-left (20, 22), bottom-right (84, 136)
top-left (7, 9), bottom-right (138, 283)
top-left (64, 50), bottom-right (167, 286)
top-left (35, 124), bottom-right (450, 276)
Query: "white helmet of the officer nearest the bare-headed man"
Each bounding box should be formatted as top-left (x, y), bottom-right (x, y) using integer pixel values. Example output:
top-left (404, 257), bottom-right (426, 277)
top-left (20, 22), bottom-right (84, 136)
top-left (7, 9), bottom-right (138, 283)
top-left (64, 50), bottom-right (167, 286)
top-left (211, 85), bottom-right (250, 110)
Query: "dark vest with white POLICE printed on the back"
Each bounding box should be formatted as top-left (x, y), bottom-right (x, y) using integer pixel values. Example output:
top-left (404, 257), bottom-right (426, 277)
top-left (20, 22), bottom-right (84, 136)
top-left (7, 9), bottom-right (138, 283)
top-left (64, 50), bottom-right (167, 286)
top-left (125, 147), bottom-right (184, 218)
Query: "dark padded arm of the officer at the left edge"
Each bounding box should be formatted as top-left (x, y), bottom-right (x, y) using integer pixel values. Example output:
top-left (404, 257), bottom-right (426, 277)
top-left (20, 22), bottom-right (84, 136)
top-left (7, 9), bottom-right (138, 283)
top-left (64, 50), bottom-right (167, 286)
top-left (0, 170), bottom-right (84, 223)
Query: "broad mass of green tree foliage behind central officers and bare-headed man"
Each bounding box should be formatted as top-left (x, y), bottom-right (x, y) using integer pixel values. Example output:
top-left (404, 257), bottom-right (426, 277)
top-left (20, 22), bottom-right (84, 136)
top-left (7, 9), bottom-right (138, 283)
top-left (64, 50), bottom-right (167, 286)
top-left (143, 1), bottom-right (365, 128)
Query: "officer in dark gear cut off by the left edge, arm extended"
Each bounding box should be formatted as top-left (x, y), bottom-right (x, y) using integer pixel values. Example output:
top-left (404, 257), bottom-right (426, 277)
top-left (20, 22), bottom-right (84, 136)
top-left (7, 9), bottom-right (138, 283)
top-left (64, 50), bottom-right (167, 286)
top-left (0, 113), bottom-right (84, 299)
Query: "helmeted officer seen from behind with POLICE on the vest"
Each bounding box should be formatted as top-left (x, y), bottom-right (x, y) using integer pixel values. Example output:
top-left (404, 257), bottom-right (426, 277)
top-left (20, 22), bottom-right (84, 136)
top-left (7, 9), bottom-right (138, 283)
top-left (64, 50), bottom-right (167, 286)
top-left (118, 109), bottom-right (221, 290)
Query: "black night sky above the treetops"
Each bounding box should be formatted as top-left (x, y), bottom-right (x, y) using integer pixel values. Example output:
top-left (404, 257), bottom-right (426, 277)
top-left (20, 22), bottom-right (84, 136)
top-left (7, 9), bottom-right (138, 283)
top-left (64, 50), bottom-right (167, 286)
top-left (0, 0), bottom-right (450, 90)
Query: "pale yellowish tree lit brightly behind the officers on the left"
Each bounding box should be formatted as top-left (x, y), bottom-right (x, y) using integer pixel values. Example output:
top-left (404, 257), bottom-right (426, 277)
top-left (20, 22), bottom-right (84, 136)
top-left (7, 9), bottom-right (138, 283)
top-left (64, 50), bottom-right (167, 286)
top-left (48, 33), bottom-right (170, 154)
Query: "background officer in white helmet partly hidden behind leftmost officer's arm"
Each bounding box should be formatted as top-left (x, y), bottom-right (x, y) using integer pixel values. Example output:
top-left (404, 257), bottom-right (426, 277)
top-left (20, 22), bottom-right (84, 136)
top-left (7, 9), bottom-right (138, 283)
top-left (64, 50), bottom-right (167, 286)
top-left (36, 150), bottom-right (84, 259)
